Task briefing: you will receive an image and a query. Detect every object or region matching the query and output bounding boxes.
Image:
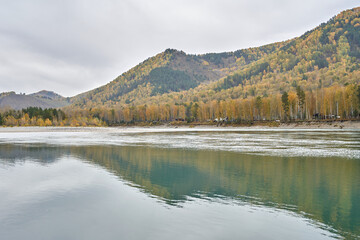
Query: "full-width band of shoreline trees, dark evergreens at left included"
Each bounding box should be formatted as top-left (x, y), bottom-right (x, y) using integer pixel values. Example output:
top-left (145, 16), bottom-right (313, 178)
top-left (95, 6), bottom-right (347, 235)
top-left (0, 85), bottom-right (360, 126)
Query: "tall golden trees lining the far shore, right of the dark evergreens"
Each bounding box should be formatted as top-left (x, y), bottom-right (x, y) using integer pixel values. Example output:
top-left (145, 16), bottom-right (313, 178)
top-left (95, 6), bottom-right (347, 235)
top-left (68, 84), bottom-right (360, 125)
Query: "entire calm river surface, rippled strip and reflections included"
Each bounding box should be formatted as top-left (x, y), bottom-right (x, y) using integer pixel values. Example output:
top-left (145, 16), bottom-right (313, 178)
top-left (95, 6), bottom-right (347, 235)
top-left (0, 128), bottom-right (360, 240)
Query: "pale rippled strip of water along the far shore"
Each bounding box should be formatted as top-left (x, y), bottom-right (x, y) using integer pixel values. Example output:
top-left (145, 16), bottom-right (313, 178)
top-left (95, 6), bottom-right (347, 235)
top-left (0, 128), bottom-right (360, 159)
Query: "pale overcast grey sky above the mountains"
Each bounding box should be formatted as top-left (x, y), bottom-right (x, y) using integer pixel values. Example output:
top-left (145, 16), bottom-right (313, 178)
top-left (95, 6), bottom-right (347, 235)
top-left (0, 0), bottom-right (360, 97)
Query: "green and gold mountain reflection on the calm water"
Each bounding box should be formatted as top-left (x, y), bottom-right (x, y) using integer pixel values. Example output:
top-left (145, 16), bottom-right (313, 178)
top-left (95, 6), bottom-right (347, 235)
top-left (0, 144), bottom-right (360, 236)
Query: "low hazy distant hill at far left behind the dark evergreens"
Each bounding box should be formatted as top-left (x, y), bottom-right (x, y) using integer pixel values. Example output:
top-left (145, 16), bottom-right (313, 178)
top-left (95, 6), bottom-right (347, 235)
top-left (0, 90), bottom-right (70, 110)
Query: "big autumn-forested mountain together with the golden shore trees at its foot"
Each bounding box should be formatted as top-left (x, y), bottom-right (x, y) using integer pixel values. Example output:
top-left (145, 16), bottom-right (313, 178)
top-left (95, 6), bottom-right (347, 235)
top-left (65, 8), bottom-right (360, 122)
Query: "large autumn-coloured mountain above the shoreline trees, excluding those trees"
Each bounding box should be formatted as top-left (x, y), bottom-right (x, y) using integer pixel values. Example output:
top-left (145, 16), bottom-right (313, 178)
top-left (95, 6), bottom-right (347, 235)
top-left (71, 8), bottom-right (360, 109)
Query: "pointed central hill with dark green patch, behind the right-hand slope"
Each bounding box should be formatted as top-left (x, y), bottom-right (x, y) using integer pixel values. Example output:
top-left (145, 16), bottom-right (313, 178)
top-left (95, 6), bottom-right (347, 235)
top-left (72, 43), bottom-right (284, 107)
